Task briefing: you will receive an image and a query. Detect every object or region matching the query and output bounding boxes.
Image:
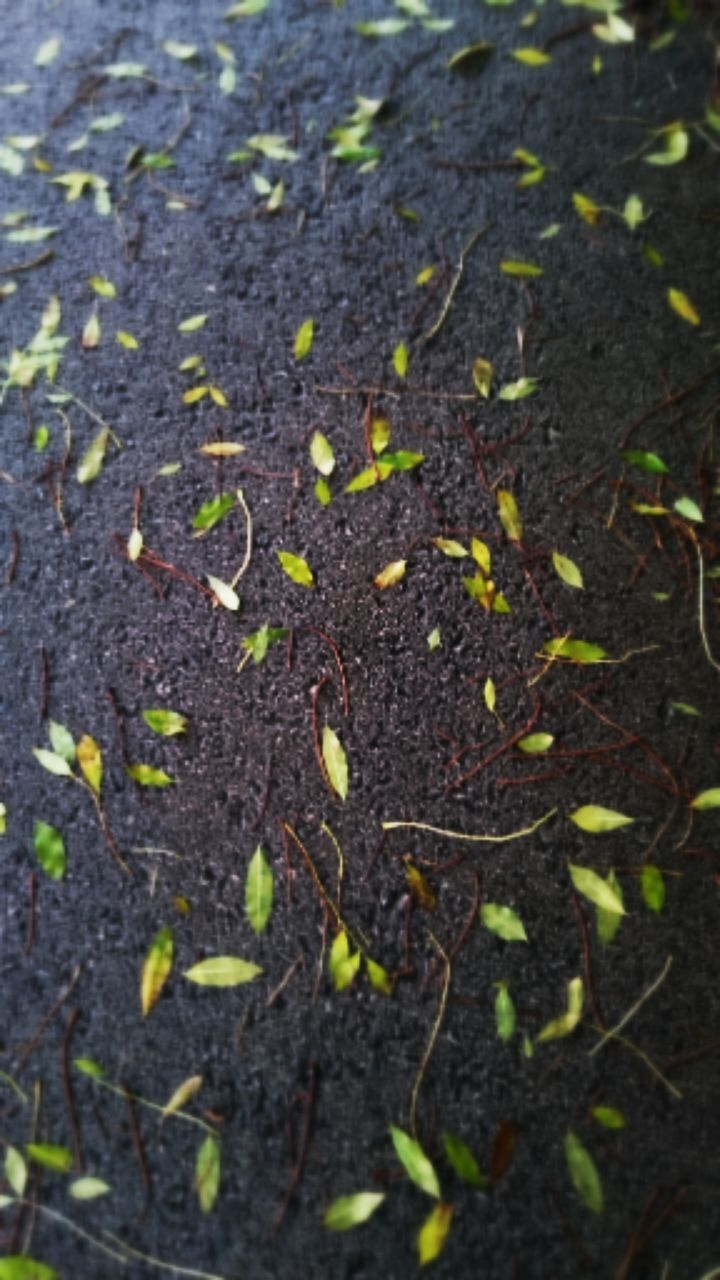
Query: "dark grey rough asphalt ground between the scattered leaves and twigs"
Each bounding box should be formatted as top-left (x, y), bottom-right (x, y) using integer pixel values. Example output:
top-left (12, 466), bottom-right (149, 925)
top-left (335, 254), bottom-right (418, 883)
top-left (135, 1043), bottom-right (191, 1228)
top-left (0, 0), bottom-right (720, 1280)
